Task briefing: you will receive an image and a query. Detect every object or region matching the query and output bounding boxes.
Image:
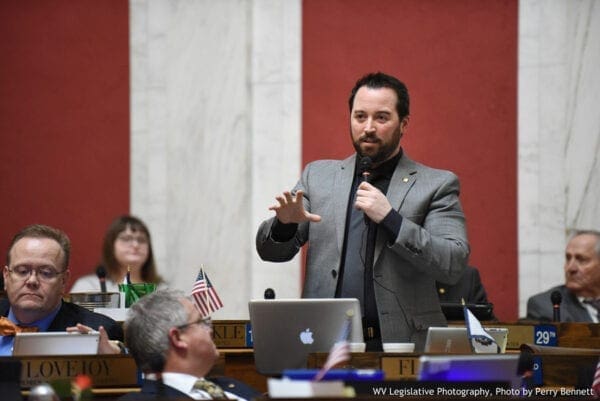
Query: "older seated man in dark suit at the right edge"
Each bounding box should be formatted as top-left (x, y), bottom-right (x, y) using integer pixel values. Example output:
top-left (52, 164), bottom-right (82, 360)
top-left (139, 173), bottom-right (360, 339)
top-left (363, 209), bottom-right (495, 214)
top-left (527, 230), bottom-right (600, 323)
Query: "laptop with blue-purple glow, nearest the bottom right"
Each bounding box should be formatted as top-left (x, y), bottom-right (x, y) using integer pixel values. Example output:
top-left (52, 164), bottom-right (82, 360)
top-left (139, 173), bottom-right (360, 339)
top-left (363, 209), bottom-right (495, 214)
top-left (417, 354), bottom-right (521, 388)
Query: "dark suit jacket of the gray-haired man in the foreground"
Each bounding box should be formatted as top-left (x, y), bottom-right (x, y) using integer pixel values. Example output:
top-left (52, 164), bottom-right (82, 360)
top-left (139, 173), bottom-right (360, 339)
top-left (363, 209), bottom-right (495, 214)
top-left (119, 377), bottom-right (262, 401)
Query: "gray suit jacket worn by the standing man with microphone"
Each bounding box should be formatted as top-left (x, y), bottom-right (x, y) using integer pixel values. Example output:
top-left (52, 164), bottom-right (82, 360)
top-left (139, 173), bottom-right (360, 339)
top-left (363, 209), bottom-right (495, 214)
top-left (256, 154), bottom-right (469, 350)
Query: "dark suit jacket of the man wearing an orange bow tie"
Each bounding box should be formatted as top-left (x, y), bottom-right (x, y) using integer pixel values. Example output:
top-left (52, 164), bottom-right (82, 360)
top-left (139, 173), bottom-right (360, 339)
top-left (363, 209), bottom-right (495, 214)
top-left (0, 299), bottom-right (123, 341)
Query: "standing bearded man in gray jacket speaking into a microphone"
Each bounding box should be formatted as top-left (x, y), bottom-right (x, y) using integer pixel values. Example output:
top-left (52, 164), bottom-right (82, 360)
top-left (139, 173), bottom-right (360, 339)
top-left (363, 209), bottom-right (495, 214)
top-left (256, 73), bottom-right (469, 351)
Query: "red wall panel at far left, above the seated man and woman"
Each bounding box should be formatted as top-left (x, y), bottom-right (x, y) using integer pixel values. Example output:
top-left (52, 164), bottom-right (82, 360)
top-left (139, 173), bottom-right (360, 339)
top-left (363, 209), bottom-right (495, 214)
top-left (0, 0), bottom-right (130, 284)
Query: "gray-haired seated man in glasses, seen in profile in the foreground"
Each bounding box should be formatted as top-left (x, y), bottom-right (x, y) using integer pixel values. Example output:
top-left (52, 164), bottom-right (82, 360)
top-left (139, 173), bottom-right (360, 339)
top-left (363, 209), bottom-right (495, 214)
top-left (119, 290), bottom-right (260, 401)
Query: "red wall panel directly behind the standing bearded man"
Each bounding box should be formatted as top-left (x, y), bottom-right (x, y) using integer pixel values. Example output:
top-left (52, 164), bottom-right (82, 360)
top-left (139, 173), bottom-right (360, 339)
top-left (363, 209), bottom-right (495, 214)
top-left (302, 0), bottom-right (518, 320)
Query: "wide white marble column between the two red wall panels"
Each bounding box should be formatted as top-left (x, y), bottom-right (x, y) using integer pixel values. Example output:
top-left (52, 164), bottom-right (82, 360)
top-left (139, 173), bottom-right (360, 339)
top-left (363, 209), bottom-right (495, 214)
top-left (130, 0), bottom-right (301, 319)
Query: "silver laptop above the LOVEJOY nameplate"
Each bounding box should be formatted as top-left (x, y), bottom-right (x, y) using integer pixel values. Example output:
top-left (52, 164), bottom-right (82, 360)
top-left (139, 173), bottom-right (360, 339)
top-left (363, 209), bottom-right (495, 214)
top-left (13, 331), bottom-right (100, 356)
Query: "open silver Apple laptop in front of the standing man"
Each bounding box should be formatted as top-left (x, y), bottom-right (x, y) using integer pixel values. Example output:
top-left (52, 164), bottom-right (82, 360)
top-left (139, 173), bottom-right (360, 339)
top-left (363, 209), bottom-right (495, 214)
top-left (248, 298), bottom-right (364, 375)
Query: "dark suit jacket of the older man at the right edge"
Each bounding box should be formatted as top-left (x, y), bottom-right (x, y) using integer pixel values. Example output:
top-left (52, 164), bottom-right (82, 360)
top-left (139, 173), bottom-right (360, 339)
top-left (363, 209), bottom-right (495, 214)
top-left (527, 285), bottom-right (592, 322)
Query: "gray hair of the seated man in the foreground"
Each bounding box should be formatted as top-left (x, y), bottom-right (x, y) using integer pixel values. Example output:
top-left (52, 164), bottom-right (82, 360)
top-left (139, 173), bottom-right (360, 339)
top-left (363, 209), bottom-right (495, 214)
top-left (124, 290), bottom-right (189, 373)
